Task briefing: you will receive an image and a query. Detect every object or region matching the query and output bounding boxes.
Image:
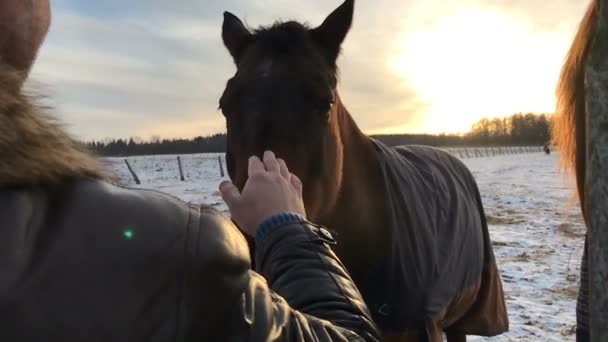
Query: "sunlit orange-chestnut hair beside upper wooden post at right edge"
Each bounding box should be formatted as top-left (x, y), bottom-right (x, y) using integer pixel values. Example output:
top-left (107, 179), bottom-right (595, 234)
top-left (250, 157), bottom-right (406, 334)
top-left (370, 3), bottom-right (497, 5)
top-left (553, 0), bottom-right (599, 219)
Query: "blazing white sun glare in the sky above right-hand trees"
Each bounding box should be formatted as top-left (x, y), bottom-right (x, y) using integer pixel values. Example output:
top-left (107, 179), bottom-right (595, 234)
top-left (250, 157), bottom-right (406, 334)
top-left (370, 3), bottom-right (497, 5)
top-left (388, 9), bottom-right (568, 133)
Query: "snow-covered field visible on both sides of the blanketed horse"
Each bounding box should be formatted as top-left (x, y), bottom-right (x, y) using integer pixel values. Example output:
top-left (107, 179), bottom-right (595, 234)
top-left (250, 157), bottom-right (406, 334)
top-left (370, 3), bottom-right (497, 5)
top-left (106, 153), bottom-right (585, 341)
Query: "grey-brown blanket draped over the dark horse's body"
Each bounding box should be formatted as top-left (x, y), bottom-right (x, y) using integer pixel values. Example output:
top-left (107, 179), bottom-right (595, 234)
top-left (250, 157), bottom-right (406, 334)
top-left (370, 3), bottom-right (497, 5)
top-left (359, 140), bottom-right (508, 336)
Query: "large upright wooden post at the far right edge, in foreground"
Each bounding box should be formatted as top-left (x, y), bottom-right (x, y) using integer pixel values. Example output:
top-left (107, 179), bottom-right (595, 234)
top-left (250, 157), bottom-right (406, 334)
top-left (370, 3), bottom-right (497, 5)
top-left (585, 0), bottom-right (608, 341)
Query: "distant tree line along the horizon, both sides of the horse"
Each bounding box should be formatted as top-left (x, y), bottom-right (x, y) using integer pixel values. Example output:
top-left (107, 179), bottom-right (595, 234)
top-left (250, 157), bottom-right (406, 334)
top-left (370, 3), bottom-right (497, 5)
top-left (85, 113), bottom-right (552, 156)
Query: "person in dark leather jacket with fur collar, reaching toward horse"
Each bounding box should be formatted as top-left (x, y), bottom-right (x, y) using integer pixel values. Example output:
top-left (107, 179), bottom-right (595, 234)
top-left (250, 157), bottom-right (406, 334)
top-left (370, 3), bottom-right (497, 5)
top-left (0, 0), bottom-right (379, 341)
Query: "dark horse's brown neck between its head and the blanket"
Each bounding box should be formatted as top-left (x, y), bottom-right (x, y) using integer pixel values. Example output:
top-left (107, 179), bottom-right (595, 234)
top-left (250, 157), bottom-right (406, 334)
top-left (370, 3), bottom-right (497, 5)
top-left (328, 103), bottom-right (388, 278)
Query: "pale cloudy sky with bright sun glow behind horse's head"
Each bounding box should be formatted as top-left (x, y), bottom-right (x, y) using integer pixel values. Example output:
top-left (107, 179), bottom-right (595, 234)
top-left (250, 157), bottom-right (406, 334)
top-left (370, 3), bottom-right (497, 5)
top-left (29, 0), bottom-right (587, 140)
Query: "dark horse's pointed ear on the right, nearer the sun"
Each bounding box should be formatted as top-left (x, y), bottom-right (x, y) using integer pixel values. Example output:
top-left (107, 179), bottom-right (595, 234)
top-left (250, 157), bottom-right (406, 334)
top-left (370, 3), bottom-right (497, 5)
top-left (311, 0), bottom-right (355, 64)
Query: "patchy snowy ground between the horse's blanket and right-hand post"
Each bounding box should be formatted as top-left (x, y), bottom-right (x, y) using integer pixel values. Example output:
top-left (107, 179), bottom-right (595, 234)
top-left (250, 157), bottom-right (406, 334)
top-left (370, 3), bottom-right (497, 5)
top-left (464, 153), bottom-right (585, 341)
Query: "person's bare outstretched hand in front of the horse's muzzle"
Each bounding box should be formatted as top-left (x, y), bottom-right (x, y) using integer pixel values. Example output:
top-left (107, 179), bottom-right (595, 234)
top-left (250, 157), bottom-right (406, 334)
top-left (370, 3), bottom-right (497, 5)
top-left (220, 151), bottom-right (306, 236)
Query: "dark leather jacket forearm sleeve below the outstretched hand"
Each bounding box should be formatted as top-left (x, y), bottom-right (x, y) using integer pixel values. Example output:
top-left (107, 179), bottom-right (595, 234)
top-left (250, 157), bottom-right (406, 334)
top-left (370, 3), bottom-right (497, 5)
top-left (245, 222), bottom-right (380, 341)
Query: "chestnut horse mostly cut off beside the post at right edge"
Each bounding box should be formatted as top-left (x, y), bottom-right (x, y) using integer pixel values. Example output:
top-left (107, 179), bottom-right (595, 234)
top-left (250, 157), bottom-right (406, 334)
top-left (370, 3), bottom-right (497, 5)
top-left (552, 0), bottom-right (599, 341)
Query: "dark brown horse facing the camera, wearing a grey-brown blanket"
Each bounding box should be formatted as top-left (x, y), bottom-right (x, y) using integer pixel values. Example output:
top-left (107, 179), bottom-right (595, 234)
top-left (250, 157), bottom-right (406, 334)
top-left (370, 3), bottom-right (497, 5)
top-left (219, 0), bottom-right (509, 342)
